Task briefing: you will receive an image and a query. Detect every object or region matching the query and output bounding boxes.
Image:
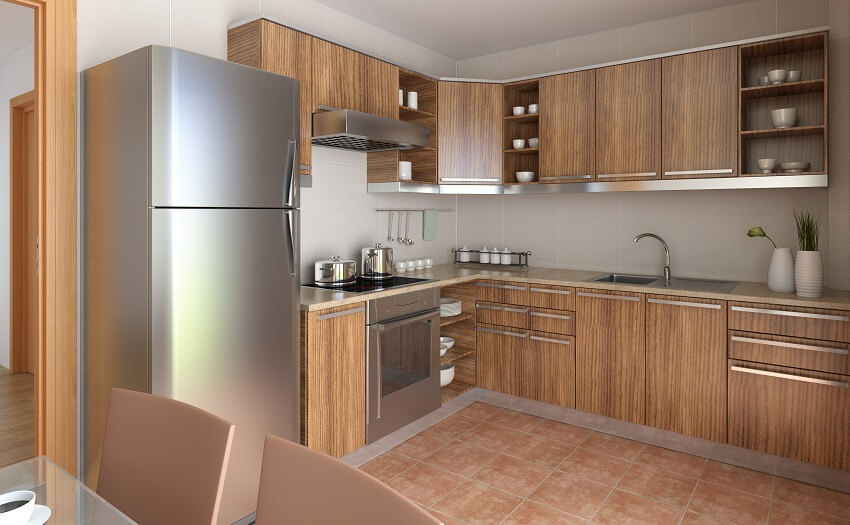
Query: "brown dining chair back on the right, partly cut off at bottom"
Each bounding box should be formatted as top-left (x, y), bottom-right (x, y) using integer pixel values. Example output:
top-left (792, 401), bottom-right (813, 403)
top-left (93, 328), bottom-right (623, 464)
top-left (256, 436), bottom-right (442, 525)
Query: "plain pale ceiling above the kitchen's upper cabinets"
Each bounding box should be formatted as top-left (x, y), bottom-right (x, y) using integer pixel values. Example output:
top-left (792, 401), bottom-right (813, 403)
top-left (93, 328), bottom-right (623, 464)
top-left (318, 0), bottom-right (742, 60)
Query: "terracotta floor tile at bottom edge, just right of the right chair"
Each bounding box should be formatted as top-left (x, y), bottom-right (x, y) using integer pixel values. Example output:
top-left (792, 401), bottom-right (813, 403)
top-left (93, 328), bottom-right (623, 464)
top-left (434, 481), bottom-right (522, 525)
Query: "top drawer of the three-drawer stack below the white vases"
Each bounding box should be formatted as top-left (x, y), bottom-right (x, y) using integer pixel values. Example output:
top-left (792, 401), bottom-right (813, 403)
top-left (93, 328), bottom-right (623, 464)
top-left (729, 303), bottom-right (850, 342)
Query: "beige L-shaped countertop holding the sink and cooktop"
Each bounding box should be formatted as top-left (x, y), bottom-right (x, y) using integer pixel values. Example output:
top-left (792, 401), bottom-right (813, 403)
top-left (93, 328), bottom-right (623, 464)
top-left (301, 264), bottom-right (850, 311)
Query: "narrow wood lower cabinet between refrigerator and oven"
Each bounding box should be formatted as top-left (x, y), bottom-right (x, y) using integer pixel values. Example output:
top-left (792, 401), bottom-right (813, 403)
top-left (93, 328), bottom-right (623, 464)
top-left (301, 303), bottom-right (366, 457)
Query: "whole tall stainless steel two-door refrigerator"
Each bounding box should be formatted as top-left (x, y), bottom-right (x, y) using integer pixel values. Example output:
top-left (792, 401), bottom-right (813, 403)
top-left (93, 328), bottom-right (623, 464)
top-left (81, 46), bottom-right (299, 523)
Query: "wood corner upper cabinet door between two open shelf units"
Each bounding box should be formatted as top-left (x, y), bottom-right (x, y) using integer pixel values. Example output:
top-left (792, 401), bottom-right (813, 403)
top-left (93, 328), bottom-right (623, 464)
top-left (440, 82), bottom-right (502, 184)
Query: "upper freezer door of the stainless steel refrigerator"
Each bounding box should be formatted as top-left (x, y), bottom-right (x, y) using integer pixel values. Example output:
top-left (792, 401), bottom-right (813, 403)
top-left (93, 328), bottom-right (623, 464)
top-left (149, 46), bottom-right (299, 208)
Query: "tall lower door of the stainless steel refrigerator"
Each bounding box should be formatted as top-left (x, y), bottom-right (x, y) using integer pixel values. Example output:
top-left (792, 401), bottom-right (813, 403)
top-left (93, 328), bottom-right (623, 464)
top-left (150, 208), bottom-right (300, 524)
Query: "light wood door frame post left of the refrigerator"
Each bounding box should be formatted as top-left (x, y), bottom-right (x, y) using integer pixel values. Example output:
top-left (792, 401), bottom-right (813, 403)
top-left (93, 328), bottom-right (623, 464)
top-left (3, 0), bottom-right (77, 474)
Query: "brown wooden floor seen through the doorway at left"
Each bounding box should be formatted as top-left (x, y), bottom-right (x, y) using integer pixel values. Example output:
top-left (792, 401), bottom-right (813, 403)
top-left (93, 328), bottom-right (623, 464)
top-left (0, 366), bottom-right (35, 467)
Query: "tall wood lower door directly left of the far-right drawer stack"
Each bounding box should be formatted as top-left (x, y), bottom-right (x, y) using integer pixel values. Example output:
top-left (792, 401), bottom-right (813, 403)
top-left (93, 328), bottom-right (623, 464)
top-left (646, 295), bottom-right (726, 442)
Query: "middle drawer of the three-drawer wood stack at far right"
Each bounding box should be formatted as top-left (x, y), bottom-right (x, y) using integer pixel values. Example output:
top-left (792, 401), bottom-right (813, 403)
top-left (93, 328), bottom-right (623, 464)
top-left (729, 332), bottom-right (850, 374)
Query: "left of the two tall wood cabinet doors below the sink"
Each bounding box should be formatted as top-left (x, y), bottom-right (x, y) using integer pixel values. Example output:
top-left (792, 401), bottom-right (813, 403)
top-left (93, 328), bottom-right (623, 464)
top-left (576, 289), bottom-right (646, 424)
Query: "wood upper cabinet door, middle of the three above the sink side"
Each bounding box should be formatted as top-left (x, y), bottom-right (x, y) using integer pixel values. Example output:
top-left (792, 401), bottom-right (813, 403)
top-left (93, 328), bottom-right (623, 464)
top-left (592, 59), bottom-right (661, 182)
